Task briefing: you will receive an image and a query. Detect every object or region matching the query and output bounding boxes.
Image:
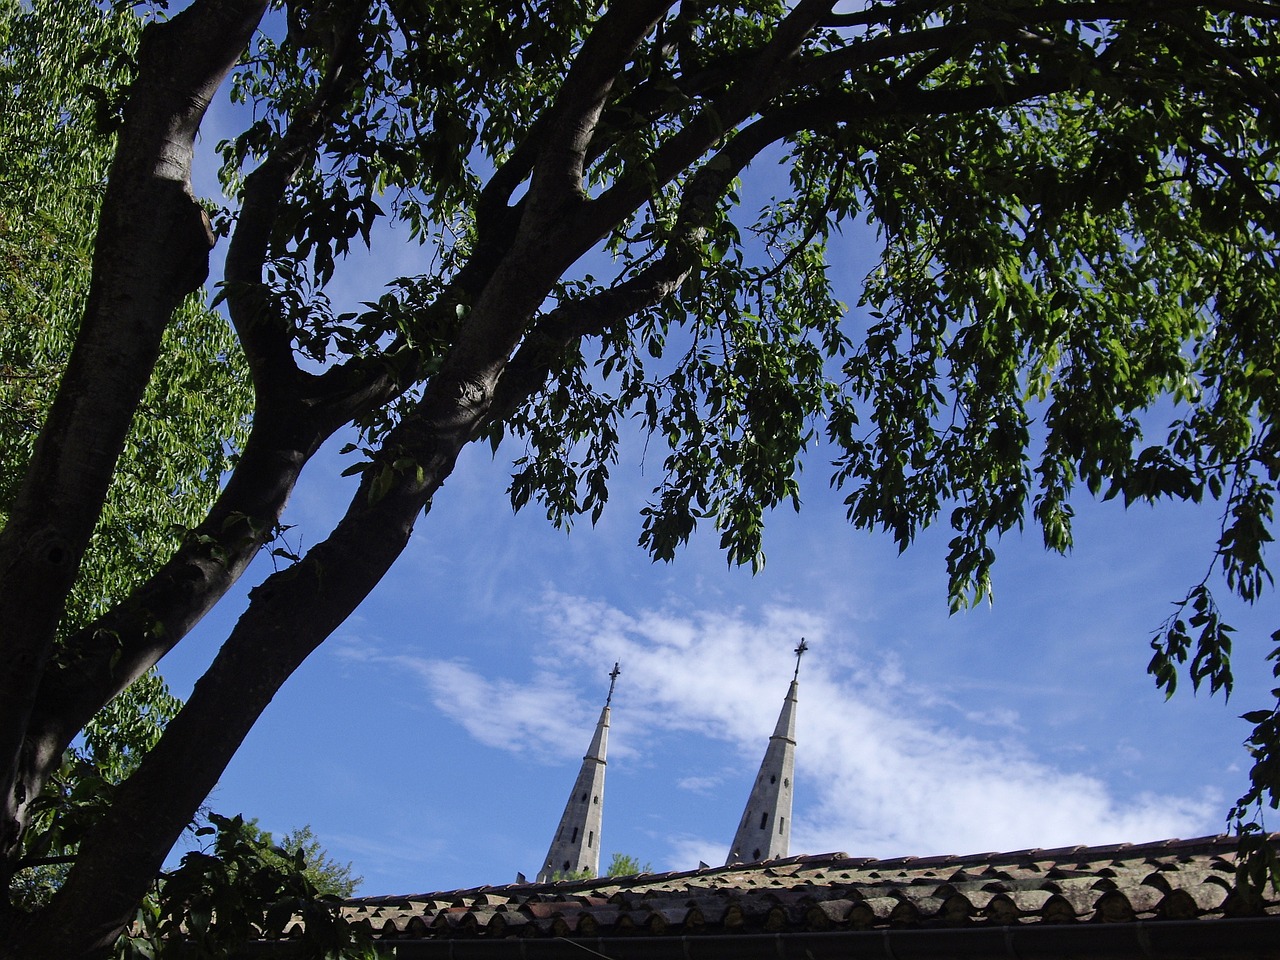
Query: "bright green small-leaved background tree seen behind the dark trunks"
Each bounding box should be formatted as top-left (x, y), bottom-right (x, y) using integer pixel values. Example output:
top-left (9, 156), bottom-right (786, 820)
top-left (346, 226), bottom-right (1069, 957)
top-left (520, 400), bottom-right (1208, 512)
top-left (0, 0), bottom-right (252, 931)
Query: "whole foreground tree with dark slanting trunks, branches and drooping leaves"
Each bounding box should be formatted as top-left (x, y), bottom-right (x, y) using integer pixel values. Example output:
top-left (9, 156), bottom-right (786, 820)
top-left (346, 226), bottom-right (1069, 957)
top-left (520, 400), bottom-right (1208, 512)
top-left (0, 0), bottom-right (1280, 957)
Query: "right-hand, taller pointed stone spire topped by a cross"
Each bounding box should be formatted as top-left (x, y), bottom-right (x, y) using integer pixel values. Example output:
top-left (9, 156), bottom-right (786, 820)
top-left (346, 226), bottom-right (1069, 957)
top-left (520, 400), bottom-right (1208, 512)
top-left (724, 637), bottom-right (809, 867)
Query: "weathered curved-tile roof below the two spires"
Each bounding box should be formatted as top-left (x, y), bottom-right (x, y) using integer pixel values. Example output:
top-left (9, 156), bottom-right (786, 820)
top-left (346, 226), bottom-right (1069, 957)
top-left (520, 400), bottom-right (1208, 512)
top-left (327, 835), bottom-right (1280, 960)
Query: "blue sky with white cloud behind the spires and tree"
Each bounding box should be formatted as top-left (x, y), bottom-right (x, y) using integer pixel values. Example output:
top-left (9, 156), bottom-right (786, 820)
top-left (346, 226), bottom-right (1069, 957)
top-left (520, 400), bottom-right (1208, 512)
top-left (161, 16), bottom-right (1277, 895)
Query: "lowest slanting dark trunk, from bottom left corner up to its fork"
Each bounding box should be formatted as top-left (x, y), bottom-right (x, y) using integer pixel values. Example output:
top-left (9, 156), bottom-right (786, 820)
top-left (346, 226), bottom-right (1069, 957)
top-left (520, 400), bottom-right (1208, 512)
top-left (0, 368), bottom-right (492, 960)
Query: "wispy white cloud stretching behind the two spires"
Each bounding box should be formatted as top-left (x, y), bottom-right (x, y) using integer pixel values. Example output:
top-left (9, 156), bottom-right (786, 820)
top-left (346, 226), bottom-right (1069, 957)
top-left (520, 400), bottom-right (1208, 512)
top-left (332, 594), bottom-right (1220, 867)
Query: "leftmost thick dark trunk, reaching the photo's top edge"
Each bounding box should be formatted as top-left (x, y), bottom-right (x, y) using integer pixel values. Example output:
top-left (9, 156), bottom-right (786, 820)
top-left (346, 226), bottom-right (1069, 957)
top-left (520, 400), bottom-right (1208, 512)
top-left (0, 0), bottom-right (265, 916)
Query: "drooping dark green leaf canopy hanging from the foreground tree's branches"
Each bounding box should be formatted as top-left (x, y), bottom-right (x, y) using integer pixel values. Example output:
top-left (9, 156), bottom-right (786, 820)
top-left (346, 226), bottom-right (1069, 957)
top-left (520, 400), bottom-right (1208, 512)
top-left (223, 0), bottom-right (1280, 849)
